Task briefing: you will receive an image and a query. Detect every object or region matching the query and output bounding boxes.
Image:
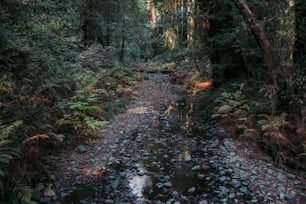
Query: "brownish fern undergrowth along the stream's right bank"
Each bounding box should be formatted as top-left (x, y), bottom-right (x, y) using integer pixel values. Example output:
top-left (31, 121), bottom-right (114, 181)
top-left (169, 51), bottom-right (306, 176)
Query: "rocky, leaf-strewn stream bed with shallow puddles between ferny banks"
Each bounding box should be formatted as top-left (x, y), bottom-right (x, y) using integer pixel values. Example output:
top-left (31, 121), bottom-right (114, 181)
top-left (33, 74), bottom-right (306, 204)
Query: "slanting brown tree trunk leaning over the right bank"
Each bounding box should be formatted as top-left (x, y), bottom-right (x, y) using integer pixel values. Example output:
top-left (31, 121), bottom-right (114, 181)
top-left (232, 0), bottom-right (277, 85)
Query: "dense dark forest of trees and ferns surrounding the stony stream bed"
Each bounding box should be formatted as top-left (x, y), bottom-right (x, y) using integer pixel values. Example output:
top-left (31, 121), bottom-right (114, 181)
top-left (0, 0), bottom-right (306, 203)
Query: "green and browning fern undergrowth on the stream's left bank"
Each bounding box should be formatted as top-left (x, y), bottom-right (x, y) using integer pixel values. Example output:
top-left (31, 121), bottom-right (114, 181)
top-left (0, 44), bottom-right (139, 201)
